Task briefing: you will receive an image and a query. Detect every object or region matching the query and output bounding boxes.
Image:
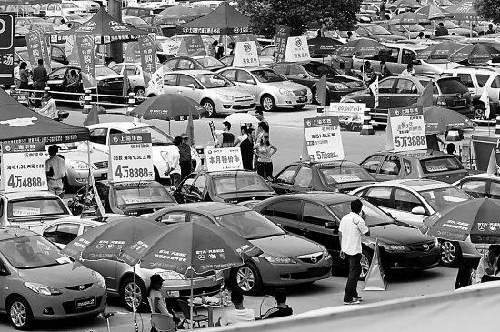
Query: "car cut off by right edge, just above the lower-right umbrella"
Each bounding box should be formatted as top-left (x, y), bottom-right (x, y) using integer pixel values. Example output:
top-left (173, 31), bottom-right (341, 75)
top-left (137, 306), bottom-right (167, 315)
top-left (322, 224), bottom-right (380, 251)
top-left (453, 174), bottom-right (500, 199)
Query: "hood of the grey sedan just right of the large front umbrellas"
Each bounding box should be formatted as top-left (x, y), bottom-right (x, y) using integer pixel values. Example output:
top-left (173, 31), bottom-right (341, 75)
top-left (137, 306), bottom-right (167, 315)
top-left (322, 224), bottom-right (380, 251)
top-left (250, 234), bottom-right (323, 257)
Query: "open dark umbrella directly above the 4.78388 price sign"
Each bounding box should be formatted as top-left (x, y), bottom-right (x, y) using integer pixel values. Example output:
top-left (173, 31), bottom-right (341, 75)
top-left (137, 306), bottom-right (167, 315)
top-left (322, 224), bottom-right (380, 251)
top-left (130, 94), bottom-right (205, 121)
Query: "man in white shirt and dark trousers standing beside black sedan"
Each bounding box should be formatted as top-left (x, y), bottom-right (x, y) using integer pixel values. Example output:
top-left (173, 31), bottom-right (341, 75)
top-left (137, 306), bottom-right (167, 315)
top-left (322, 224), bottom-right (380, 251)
top-left (339, 199), bottom-right (370, 305)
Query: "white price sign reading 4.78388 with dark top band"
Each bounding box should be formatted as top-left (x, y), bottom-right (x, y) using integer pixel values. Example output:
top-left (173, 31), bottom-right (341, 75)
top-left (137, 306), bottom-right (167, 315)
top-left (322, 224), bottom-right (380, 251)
top-left (108, 133), bottom-right (155, 182)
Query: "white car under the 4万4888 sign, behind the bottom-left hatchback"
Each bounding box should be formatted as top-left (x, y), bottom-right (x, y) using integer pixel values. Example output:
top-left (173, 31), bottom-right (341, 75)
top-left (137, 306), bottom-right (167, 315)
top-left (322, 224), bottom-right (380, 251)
top-left (0, 191), bottom-right (71, 233)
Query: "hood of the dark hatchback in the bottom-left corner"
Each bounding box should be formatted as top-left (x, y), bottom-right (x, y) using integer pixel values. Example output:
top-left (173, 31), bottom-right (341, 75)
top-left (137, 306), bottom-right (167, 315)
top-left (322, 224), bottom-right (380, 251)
top-left (18, 263), bottom-right (99, 288)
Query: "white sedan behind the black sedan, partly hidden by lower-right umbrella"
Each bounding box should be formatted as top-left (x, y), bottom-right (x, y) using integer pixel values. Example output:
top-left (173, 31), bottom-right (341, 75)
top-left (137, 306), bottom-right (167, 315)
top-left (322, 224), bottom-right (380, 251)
top-left (351, 179), bottom-right (471, 265)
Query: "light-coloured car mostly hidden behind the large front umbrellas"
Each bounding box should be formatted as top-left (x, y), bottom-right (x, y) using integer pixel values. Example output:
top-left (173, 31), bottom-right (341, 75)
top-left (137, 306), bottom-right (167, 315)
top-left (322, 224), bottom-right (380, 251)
top-left (43, 217), bottom-right (224, 311)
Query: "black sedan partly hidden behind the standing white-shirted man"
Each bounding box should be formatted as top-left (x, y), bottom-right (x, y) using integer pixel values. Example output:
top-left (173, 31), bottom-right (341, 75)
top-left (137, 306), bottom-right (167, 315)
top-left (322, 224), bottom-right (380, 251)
top-left (254, 193), bottom-right (441, 278)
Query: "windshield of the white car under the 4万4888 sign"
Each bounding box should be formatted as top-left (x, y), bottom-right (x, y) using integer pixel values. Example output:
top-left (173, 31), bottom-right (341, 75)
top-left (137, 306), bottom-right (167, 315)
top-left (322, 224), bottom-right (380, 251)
top-left (7, 197), bottom-right (70, 222)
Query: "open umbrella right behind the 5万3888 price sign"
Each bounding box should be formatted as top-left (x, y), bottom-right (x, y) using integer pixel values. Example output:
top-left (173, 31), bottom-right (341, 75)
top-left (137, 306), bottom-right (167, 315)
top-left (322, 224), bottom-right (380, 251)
top-left (424, 106), bottom-right (475, 135)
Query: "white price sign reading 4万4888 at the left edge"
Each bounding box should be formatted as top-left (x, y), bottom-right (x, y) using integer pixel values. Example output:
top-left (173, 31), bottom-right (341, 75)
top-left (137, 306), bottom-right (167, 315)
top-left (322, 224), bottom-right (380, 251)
top-left (0, 143), bottom-right (48, 192)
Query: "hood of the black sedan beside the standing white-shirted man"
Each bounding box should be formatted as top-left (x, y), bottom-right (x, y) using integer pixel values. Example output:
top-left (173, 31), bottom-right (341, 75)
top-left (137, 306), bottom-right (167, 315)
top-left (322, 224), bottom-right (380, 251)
top-left (370, 225), bottom-right (434, 245)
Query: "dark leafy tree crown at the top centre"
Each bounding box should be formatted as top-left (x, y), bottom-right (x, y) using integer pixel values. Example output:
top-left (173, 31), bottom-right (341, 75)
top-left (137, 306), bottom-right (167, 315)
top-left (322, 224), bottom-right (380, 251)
top-left (237, 0), bottom-right (362, 37)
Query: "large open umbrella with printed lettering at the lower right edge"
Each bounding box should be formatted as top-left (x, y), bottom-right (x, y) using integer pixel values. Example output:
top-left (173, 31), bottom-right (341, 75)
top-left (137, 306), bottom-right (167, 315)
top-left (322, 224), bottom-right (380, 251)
top-left (425, 198), bottom-right (500, 244)
